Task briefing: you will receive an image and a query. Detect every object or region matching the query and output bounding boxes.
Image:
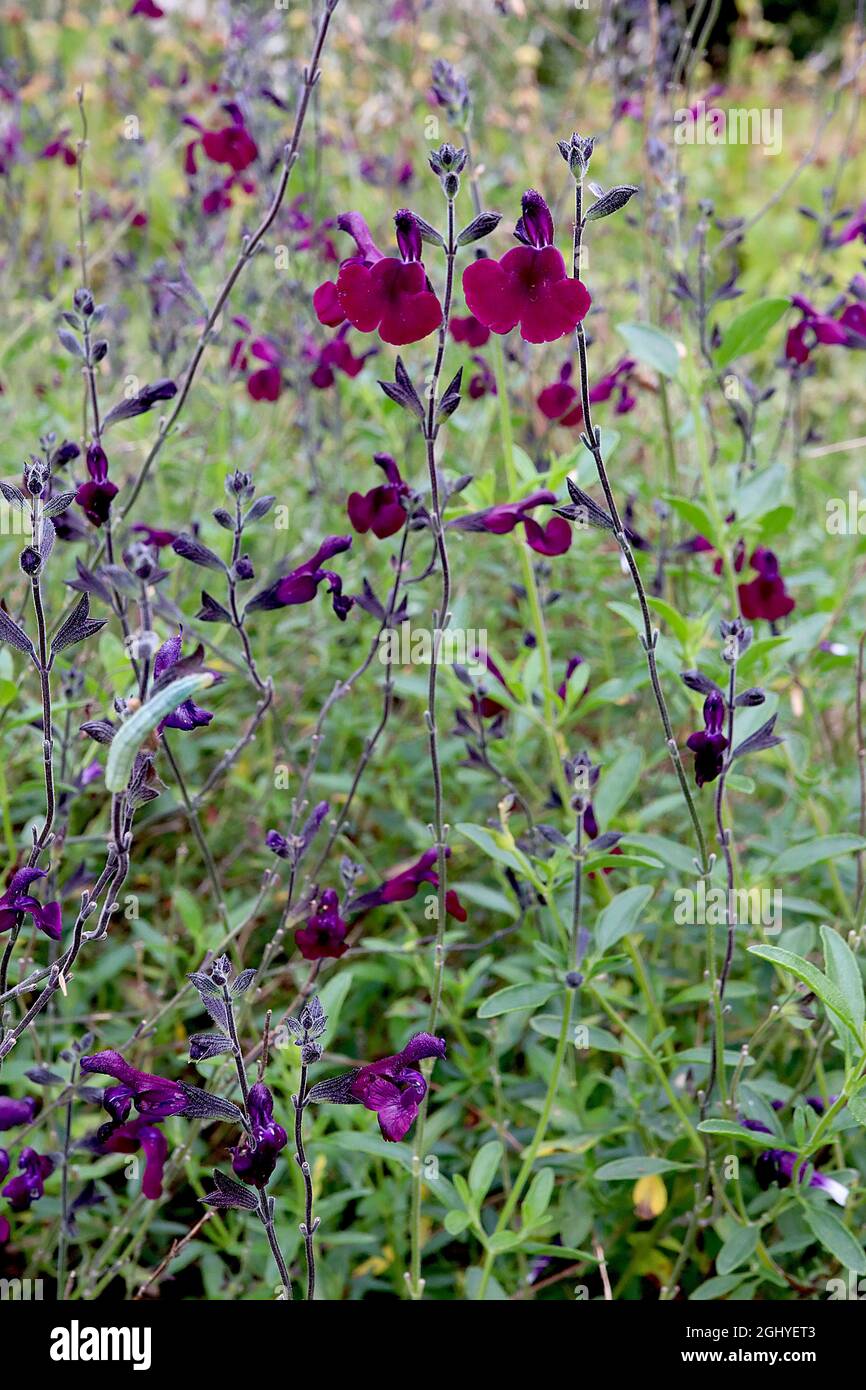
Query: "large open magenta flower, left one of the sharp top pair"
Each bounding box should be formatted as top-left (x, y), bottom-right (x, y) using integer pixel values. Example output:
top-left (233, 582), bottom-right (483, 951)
top-left (326, 209), bottom-right (442, 348)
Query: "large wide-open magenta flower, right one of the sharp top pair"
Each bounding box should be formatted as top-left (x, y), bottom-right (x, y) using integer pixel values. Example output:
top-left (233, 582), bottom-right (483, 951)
top-left (463, 189), bottom-right (591, 343)
